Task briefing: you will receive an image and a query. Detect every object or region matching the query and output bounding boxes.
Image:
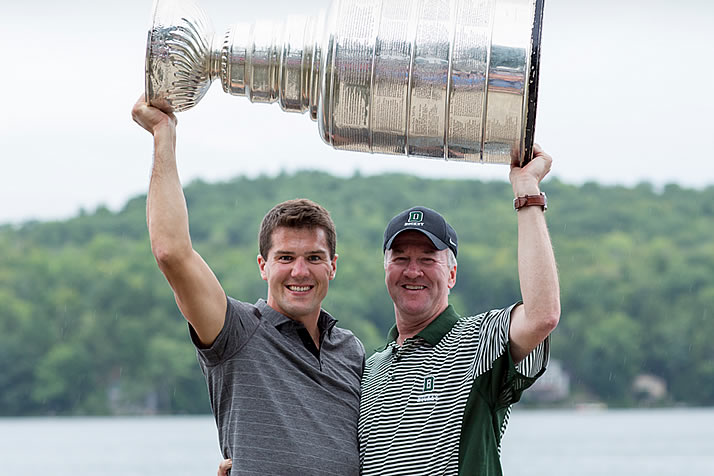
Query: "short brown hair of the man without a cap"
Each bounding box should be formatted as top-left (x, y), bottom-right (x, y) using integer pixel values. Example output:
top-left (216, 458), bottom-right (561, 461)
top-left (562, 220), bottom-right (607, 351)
top-left (258, 198), bottom-right (337, 259)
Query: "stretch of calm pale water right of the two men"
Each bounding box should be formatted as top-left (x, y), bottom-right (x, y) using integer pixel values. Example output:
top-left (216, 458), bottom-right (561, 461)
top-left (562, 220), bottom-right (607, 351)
top-left (501, 408), bottom-right (714, 476)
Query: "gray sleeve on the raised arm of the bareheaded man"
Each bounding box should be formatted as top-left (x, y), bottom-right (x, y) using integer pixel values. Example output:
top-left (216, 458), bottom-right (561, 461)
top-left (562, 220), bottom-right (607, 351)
top-left (188, 297), bottom-right (260, 367)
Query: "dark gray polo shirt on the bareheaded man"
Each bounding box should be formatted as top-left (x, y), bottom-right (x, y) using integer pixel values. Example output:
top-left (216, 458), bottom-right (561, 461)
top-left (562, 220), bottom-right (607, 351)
top-left (189, 297), bottom-right (364, 476)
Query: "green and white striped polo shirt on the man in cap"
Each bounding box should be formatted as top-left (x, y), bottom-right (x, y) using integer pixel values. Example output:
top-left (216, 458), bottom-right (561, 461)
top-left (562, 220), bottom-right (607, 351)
top-left (359, 304), bottom-right (549, 476)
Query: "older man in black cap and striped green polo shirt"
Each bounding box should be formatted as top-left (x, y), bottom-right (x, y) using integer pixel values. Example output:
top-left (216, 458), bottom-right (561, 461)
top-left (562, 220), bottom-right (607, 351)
top-left (359, 146), bottom-right (560, 476)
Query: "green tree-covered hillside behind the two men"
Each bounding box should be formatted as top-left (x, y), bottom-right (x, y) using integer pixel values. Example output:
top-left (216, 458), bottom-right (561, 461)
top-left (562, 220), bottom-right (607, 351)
top-left (0, 172), bottom-right (714, 416)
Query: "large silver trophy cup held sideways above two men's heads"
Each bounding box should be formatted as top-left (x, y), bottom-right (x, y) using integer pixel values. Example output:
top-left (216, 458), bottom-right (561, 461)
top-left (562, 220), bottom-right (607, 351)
top-left (146, 0), bottom-right (544, 165)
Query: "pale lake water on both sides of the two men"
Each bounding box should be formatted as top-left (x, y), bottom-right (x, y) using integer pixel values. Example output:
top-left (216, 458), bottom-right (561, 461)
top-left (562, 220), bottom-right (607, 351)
top-left (0, 408), bottom-right (714, 476)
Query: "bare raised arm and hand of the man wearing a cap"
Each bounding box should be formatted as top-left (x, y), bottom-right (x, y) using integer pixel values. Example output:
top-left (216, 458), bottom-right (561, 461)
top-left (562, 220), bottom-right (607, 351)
top-left (510, 144), bottom-right (560, 362)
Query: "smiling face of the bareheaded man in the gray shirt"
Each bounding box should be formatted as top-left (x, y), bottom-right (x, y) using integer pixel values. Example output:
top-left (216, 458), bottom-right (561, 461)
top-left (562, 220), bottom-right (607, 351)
top-left (258, 226), bottom-right (337, 321)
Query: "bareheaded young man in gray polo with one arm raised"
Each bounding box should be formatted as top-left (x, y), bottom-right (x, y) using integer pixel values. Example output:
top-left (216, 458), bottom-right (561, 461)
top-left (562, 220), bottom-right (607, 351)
top-left (132, 99), bottom-right (364, 475)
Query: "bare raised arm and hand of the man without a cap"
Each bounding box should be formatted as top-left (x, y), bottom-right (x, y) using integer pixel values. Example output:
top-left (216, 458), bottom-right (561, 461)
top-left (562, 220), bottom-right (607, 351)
top-left (131, 97), bottom-right (227, 345)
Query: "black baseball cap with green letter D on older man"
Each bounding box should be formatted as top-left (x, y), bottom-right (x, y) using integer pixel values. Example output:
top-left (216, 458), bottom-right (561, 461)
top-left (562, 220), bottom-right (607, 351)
top-left (382, 207), bottom-right (458, 256)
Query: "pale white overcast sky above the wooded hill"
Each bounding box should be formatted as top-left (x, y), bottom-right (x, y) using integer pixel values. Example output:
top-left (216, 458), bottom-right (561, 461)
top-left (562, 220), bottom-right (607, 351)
top-left (0, 0), bottom-right (714, 223)
